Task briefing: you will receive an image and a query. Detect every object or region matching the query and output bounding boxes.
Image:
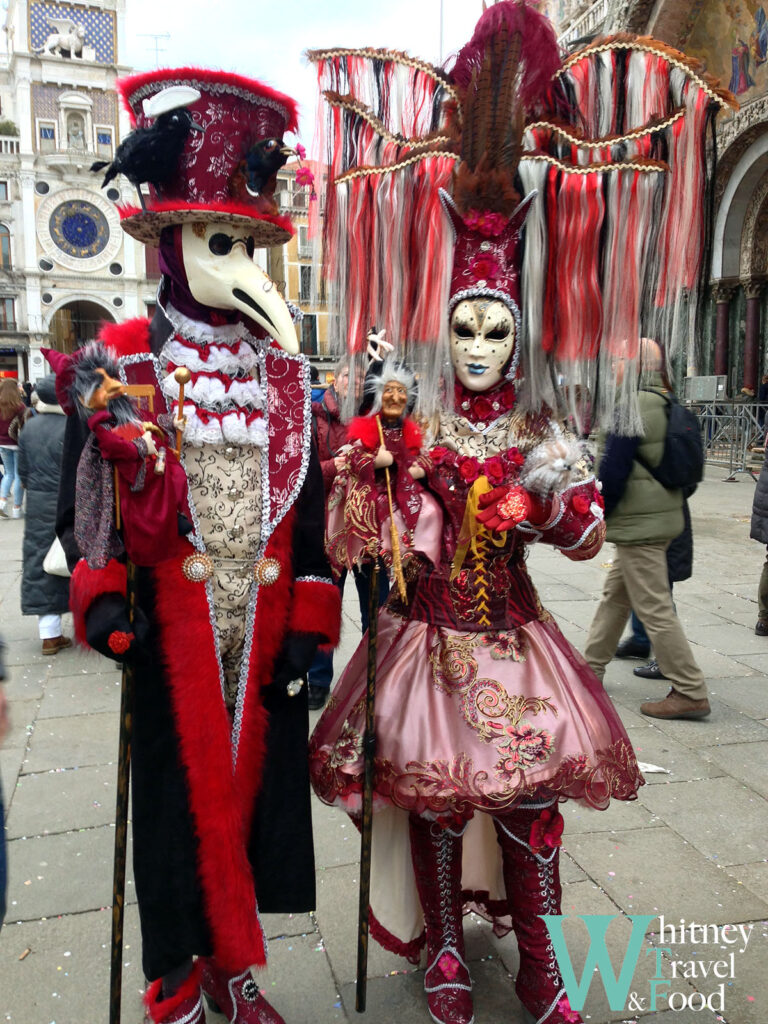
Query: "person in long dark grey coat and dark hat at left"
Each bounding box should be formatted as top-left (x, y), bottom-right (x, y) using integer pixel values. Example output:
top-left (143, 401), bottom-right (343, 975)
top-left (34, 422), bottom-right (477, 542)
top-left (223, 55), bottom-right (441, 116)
top-left (17, 374), bottom-right (72, 654)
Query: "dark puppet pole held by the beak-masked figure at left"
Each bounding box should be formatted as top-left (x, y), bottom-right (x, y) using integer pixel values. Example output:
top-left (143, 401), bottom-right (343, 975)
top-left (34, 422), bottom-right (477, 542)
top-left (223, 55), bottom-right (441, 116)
top-left (110, 561), bottom-right (136, 1024)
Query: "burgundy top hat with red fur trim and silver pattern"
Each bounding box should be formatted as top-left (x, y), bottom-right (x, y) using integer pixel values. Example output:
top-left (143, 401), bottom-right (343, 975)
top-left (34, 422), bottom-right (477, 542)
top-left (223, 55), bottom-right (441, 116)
top-left (118, 68), bottom-right (298, 247)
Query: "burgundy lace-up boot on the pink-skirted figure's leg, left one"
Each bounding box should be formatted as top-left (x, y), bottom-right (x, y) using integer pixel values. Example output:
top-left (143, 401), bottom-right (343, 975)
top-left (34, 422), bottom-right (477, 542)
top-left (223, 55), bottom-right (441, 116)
top-left (411, 814), bottom-right (474, 1024)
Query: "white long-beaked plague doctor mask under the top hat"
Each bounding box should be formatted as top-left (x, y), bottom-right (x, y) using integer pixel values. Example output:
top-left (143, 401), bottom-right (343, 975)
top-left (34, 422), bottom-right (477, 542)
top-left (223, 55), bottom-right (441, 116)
top-left (181, 221), bottom-right (299, 355)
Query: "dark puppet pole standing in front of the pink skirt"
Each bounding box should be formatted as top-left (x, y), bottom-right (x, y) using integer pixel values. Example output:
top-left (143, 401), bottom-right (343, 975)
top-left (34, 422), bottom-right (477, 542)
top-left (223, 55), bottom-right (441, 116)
top-left (354, 558), bottom-right (379, 1014)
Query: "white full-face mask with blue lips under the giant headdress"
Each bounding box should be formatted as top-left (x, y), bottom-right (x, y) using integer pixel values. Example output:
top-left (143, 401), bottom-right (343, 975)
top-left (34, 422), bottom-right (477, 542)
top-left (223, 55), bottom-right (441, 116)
top-left (451, 299), bottom-right (515, 391)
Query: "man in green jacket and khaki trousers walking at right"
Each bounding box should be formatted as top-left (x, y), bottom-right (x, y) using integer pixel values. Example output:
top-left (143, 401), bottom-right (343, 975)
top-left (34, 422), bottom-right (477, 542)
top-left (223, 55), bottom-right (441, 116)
top-left (584, 338), bottom-right (711, 719)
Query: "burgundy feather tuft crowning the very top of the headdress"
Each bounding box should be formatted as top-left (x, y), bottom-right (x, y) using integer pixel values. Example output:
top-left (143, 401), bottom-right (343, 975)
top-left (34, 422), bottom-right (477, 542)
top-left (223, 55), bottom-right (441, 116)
top-left (451, 0), bottom-right (561, 108)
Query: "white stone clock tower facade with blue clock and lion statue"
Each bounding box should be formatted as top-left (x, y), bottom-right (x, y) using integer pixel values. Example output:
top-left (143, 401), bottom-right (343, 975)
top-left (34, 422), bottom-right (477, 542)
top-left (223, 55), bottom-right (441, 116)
top-left (0, 0), bottom-right (157, 381)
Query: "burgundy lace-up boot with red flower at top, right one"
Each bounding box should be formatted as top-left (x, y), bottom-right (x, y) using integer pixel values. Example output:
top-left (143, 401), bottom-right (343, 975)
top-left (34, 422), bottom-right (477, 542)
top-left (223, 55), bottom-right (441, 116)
top-left (494, 800), bottom-right (583, 1024)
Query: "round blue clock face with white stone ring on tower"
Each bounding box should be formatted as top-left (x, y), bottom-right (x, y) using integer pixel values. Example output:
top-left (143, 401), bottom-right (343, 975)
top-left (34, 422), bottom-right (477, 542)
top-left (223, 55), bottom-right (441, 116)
top-left (35, 188), bottom-right (123, 272)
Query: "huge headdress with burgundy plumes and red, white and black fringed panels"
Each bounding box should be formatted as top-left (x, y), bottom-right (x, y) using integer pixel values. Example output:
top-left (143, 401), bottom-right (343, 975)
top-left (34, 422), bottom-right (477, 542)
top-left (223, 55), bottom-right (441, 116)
top-left (309, 0), bottom-right (735, 432)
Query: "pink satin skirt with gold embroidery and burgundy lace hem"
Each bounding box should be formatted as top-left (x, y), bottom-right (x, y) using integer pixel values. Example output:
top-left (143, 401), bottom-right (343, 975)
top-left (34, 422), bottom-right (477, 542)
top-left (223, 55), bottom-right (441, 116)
top-left (310, 610), bottom-right (643, 824)
